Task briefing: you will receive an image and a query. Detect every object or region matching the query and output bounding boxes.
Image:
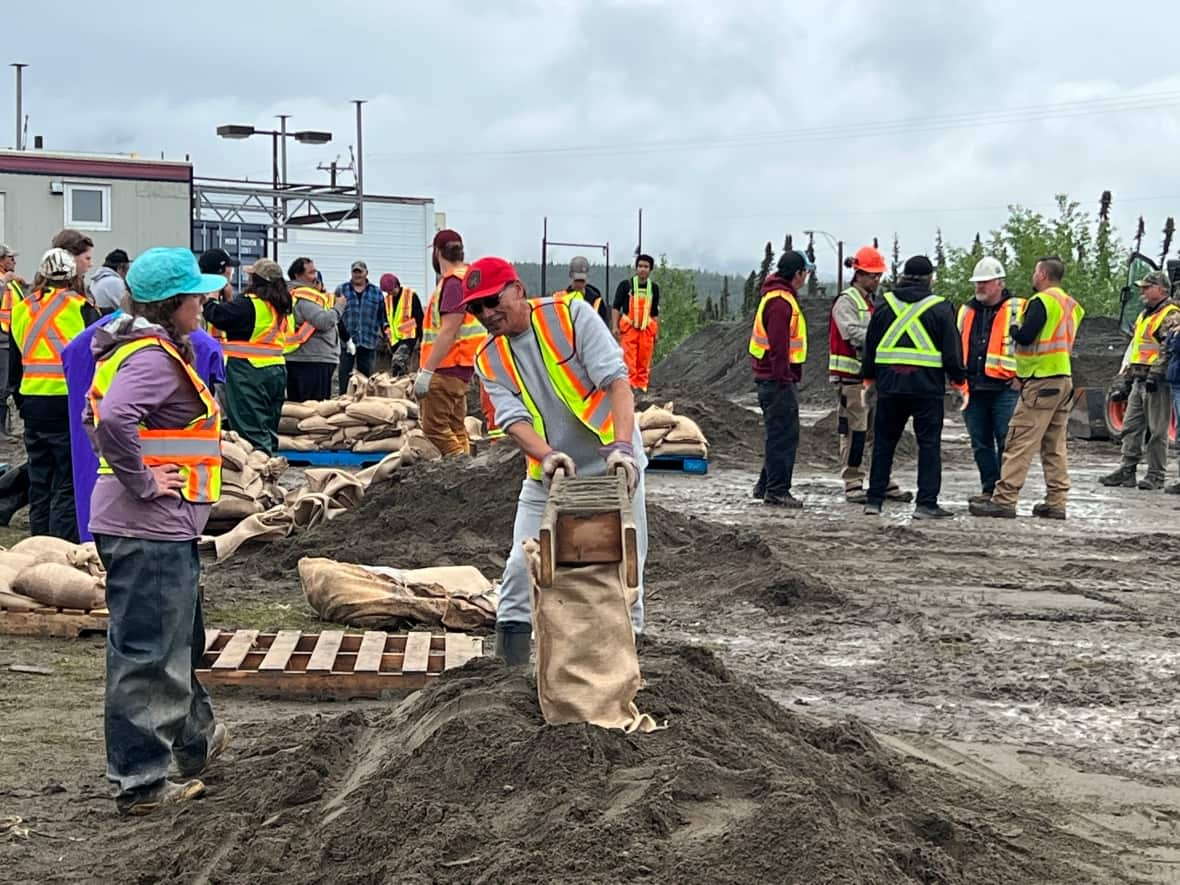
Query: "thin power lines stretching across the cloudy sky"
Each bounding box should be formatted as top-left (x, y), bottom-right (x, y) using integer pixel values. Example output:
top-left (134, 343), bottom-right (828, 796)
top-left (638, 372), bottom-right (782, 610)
top-left (369, 90), bottom-right (1180, 159)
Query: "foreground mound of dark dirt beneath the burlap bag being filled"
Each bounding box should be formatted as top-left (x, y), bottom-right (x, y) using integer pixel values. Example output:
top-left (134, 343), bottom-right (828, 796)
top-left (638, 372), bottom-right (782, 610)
top-left (78, 643), bottom-right (1093, 885)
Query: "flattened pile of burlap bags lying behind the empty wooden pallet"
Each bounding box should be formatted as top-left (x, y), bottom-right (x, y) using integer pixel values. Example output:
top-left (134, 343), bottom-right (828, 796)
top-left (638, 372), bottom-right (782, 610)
top-left (299, 557), bottom-right (498, 630)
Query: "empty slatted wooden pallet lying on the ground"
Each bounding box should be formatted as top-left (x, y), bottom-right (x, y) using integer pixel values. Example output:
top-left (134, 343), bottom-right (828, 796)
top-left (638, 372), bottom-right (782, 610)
top-left (197, 630), bottom-right (484, 699)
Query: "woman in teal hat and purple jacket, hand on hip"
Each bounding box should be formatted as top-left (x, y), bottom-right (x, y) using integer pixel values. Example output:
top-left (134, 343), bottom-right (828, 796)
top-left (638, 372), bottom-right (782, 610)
top-left (85, 249), bottom-right (225, 814)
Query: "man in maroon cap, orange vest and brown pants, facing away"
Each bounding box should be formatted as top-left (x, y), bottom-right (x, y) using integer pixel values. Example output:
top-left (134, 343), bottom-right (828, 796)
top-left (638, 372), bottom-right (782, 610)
top-left (414, 229), bottom-right (485, 458)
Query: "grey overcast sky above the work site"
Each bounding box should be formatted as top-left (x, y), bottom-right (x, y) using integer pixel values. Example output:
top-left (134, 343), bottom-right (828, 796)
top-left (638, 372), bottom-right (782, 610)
top-left (0, 0), bottom-right (1180, 271)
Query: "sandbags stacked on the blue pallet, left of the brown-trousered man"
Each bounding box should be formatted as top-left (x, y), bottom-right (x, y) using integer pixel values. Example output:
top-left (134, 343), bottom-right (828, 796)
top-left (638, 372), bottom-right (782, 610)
top-left (278, 394), bottom-right (418, 453)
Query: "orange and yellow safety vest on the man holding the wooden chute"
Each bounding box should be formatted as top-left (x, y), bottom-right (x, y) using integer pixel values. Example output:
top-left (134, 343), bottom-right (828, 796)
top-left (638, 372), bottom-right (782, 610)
top-left (476, 299), bottom-right (615, 479)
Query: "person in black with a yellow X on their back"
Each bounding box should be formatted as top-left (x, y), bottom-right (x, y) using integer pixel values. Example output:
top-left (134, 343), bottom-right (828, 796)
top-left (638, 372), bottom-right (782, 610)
top-left (861, 255), bottom-right (966, 519)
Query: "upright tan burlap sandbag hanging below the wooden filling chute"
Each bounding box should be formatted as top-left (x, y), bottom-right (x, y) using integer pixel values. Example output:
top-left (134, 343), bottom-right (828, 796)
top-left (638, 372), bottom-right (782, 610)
top-left (525, 539), bottom-right (658, 733)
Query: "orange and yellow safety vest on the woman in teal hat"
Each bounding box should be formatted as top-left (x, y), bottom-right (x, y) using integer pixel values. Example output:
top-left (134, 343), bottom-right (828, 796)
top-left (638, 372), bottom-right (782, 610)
top-left (89, 337), bottom-right (222, 504)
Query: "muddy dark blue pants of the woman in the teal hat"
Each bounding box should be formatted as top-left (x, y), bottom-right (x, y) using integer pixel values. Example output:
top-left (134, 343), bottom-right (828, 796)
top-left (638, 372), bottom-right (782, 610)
top-left (94, 535), bottom-right (214, 794)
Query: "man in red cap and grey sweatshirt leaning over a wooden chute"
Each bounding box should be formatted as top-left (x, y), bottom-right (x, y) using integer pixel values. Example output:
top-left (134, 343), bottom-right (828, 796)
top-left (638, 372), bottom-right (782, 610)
top-left (463, 257), bottom-right (648, 664)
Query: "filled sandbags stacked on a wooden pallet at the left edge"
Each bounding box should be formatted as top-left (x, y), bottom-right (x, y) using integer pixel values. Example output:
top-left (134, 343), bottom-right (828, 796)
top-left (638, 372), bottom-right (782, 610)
top-left (0, 535), bottom-right (106, 611)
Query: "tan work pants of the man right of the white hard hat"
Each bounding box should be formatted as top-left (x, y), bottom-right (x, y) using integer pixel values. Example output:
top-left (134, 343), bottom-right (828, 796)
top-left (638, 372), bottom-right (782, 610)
top-left (991, 378), bottom-right (1074, 510)
